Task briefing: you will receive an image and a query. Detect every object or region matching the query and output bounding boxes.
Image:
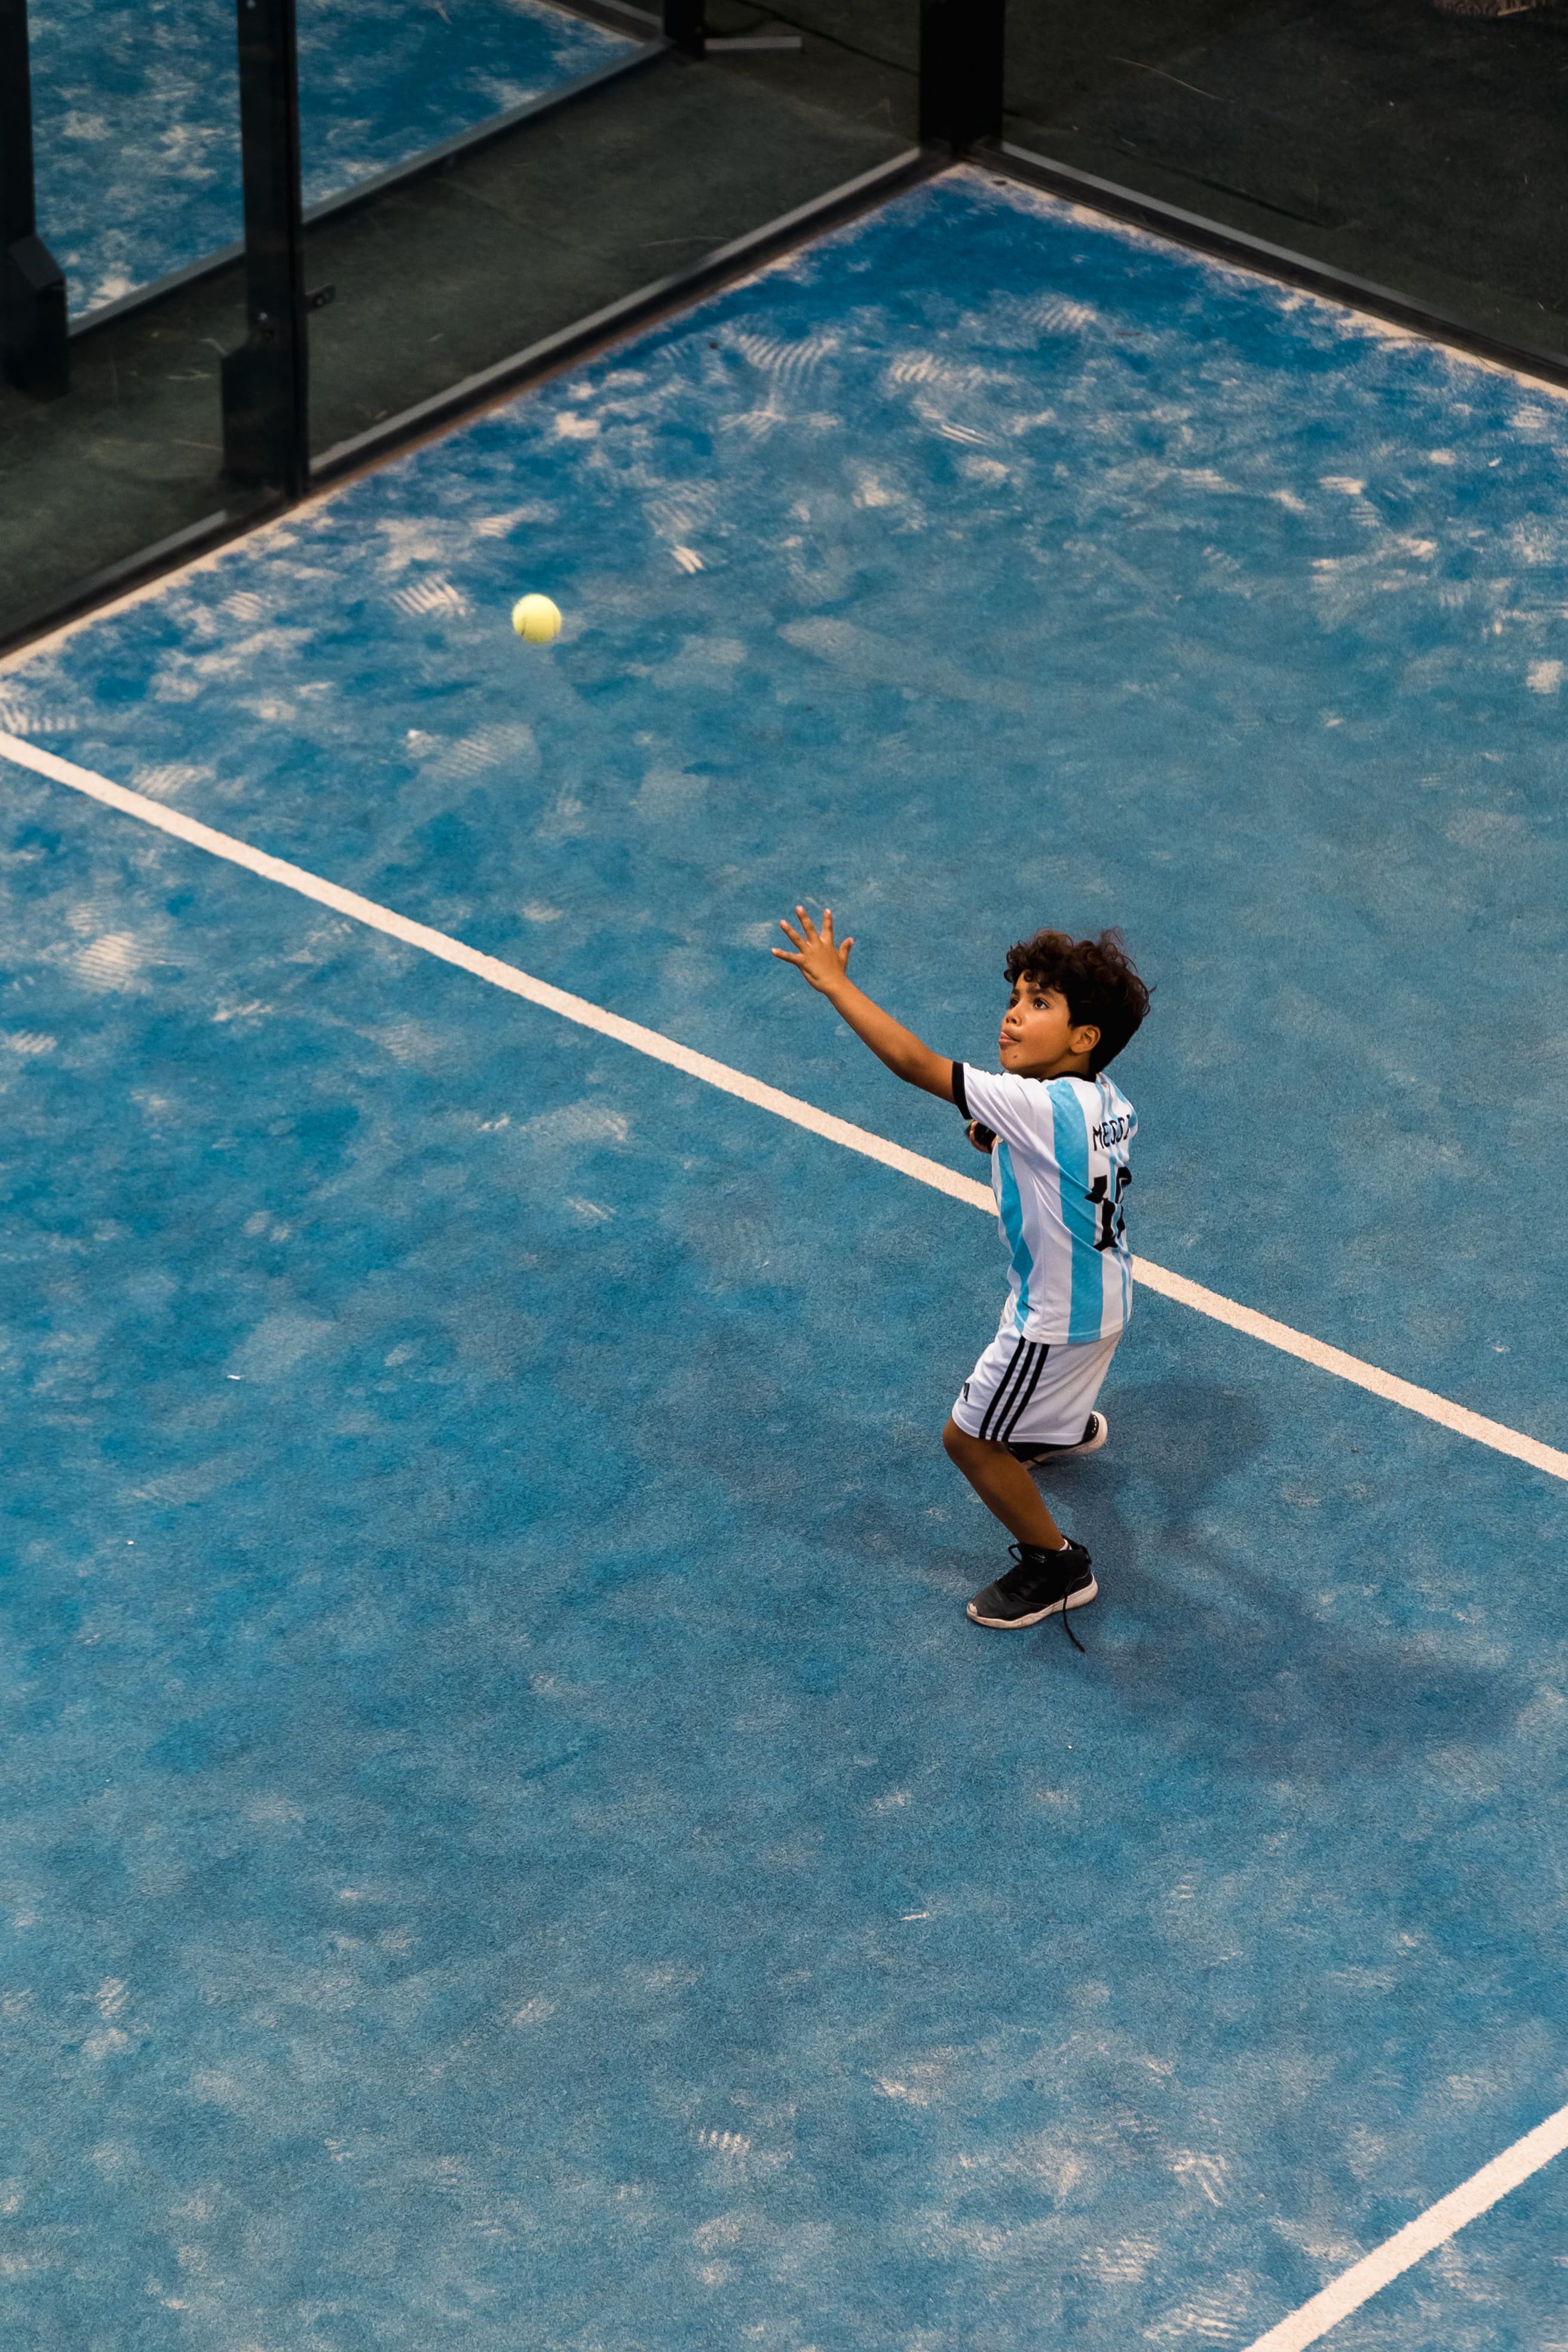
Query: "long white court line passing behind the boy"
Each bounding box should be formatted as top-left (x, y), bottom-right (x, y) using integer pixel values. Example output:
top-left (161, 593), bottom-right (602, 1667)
top-left (0, 734), bottom-right (1568, 1480)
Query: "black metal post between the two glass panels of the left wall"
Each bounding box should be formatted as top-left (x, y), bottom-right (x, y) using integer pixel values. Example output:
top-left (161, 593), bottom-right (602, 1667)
top-left (223, 0), bottom-right (310, 498)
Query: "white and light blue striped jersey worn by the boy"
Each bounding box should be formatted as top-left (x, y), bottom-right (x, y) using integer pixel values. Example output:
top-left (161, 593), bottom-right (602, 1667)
top-left (952, 1063), bottom-right (1138, 1348)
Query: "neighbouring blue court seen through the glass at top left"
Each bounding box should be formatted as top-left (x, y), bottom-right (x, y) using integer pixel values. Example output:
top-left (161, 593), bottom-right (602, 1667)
top-left (30, 0), bottom-right (637, 315)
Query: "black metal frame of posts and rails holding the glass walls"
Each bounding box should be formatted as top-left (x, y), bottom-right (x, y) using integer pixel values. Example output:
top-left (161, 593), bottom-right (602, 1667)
top-left (15, 0), bottom-right (1568, 644)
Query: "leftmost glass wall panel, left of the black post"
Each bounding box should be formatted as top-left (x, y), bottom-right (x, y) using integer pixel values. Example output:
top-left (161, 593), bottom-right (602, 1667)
top-left (0, 0), bottom-right (261, 640)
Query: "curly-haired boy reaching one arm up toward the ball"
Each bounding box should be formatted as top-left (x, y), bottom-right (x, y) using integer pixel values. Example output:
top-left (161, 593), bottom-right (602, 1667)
top-left (773, 905), bottom-right (1150, 1649)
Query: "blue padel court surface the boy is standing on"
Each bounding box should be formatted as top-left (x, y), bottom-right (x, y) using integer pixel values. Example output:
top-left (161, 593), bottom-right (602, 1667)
top-left (0, 169), bottom-right (1568, 2352)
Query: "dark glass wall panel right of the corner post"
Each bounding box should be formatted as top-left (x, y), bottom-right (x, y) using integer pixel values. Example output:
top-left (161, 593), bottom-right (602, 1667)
top-left (1006, 0), bottom-right (1568, 355)
